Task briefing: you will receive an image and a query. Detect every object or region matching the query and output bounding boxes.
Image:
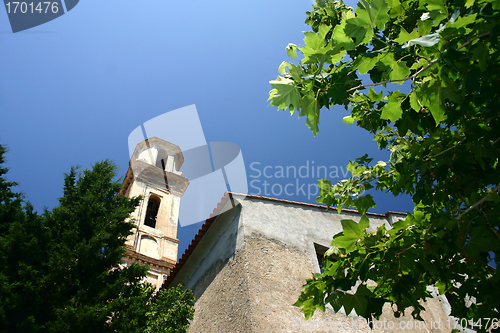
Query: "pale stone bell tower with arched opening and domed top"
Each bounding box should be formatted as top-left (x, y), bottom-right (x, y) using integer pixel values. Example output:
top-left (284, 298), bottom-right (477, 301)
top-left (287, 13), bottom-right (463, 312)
top-left (119, 137), bottom-right (189, 289)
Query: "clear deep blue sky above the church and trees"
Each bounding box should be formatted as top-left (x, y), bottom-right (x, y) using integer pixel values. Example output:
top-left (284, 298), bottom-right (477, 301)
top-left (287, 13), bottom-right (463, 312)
top-left (0, 0), bottom-right (412, 254)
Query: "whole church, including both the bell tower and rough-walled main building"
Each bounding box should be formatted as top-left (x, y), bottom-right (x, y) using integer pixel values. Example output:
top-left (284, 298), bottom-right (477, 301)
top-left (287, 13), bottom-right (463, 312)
top-left (122, 138), bottom-right (454, 333)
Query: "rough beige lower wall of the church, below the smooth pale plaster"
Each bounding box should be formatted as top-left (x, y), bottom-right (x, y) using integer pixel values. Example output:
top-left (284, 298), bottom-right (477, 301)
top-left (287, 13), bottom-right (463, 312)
top-left (188, 234), bottom-right (451, 333)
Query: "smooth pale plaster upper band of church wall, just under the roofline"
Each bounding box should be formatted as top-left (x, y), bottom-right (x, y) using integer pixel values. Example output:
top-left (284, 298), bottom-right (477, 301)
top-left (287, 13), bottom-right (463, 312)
top-left (172, 197), bottom-right (404, 298)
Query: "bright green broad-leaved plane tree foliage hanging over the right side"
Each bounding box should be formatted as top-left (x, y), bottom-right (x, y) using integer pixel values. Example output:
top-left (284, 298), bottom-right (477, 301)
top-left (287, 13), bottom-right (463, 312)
top-left (269, 0), bottom-right (500, 331)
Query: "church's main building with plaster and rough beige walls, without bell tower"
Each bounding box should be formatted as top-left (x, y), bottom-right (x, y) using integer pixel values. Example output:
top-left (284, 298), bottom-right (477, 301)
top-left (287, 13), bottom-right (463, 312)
top-left (164, 194), bottom-right (451, 333)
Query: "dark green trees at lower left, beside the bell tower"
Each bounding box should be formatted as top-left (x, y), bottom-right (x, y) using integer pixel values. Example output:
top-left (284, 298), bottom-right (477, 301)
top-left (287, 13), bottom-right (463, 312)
top-left (0, 145), bottom-right (194, 333)
